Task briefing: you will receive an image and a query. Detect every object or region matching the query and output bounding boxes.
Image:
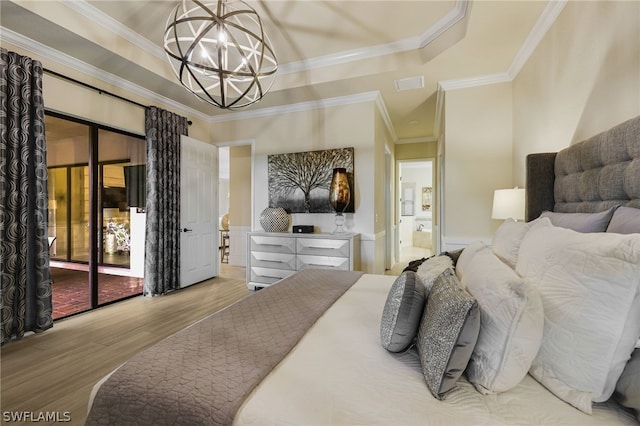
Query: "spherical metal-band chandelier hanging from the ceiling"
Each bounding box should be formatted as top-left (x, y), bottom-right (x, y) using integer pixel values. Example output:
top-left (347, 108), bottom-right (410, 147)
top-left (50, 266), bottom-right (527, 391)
top-left (164, 0), bottom-right (278, 109)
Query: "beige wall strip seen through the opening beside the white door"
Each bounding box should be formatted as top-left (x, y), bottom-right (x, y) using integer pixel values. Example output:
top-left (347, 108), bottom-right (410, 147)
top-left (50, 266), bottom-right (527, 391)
top-left (229, 145), bottom-right (251, 227)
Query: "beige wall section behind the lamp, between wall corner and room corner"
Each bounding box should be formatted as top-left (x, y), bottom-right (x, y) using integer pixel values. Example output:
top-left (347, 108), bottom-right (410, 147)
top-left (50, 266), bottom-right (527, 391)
top-left (441, 83), bottom-right (512, 246)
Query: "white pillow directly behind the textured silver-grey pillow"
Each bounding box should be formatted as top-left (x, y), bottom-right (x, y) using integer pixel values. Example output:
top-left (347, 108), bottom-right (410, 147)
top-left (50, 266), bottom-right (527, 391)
top-left (462, 247), bottom-right (544, 394)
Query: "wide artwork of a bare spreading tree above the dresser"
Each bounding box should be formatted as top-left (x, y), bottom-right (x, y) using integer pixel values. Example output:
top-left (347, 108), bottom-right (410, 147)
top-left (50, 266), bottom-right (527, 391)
top-left (267, 148), bottom-right (355, 213)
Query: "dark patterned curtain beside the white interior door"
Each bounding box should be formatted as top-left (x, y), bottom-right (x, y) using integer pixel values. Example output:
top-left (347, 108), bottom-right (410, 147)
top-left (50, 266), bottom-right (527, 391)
top-left (143, 107), bottom-right (189, 296)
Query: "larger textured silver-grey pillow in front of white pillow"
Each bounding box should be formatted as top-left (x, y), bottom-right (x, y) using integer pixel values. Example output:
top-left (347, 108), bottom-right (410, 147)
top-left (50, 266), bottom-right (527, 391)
top-left (417, 269), bottom-right (480, 399)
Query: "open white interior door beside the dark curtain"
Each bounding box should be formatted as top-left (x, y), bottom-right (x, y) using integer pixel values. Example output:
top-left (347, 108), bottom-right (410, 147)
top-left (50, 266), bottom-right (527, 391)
top-left (180, 136), bottom-right (218, 287)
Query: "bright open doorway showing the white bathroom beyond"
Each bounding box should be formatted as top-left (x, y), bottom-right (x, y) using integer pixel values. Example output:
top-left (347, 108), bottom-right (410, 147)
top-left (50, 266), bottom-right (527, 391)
top-left (397, 159), bottom-right (435, 264)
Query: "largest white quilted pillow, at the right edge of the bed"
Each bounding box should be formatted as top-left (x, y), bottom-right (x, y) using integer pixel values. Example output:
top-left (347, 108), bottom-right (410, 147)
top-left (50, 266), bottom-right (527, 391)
top-left (516, 218), bottom-right (640, 413)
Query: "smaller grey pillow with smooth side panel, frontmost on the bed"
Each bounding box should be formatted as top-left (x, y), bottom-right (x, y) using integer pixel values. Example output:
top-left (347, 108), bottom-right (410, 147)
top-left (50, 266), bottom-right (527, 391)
top-left (380, 271), bottom-right (425, 352)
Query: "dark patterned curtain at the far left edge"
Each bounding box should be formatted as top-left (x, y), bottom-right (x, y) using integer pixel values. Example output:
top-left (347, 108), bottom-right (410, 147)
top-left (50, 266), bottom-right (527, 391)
top-left (0, 49), bottom-right (53, 344)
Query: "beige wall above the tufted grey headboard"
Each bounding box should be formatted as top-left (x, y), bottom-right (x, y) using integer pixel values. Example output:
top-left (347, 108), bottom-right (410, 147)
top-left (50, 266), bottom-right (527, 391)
top-left (513, 1), bottom-right (640, 185)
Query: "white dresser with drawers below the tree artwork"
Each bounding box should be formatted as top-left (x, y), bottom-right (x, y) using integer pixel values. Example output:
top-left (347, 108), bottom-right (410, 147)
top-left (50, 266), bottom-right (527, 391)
top-left (247, 232), bottom-right (360, 290)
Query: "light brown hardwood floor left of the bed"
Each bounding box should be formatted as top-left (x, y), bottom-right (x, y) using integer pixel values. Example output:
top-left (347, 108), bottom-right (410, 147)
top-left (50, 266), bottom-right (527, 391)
top-left (0, 264), bottom-right (249, 425)
